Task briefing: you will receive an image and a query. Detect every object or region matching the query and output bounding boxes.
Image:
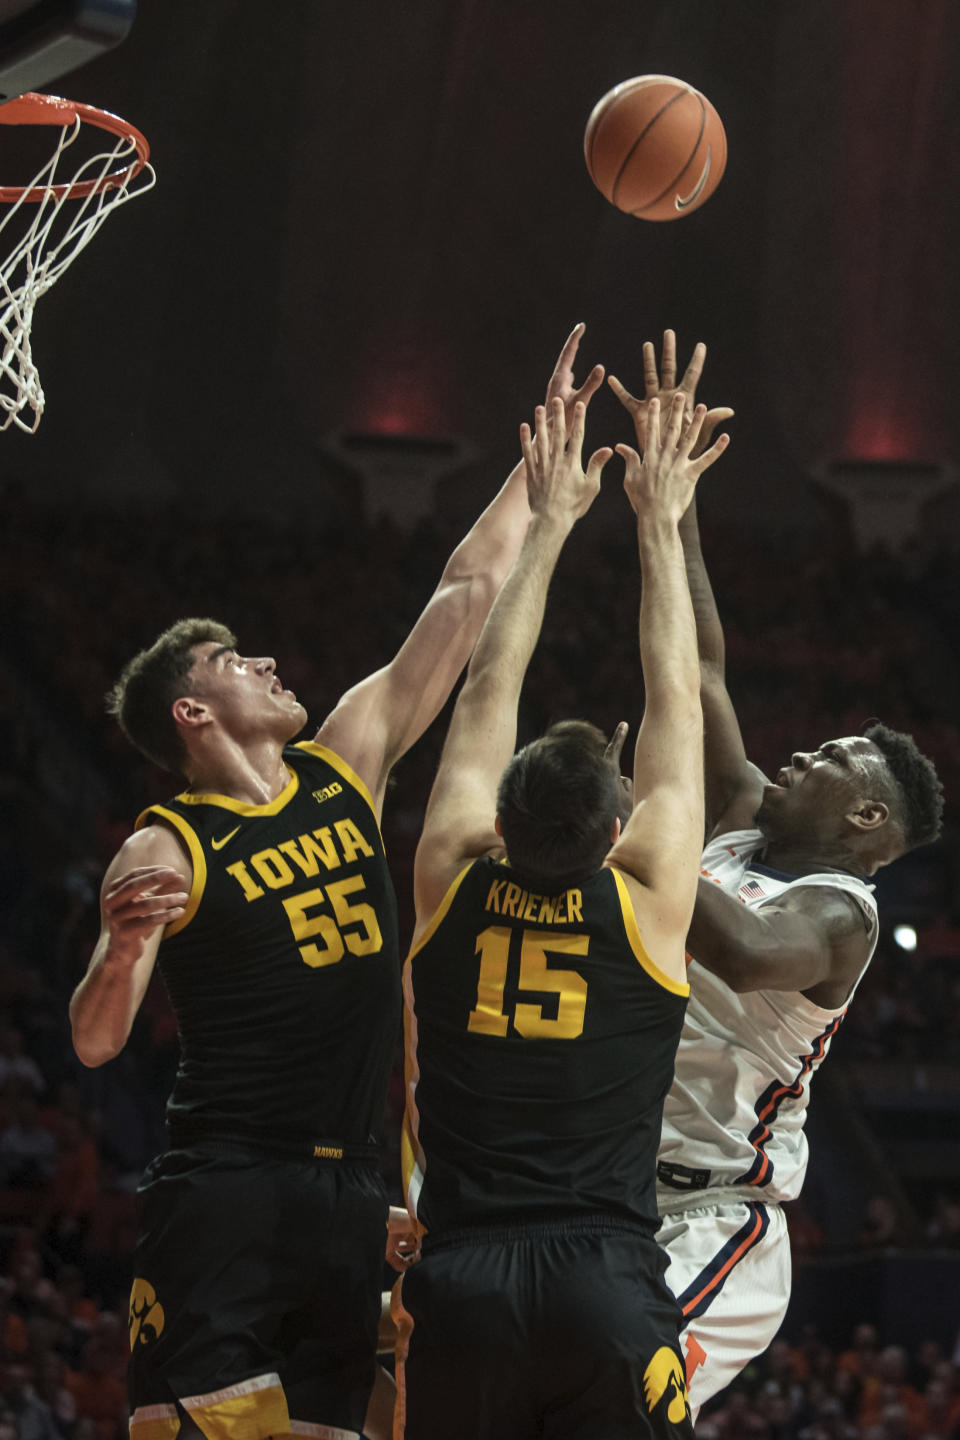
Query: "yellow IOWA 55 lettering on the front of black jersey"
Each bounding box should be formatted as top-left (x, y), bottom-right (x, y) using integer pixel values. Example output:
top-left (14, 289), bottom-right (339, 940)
top-left (226, 819), bottom-right (383, 969)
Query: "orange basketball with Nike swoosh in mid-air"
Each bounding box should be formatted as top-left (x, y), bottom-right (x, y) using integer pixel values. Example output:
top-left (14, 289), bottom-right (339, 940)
top-left (583, 75), bottom-right (727, 220)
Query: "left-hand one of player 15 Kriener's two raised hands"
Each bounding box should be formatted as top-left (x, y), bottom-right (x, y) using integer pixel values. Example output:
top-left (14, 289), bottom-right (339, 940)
top-left (520, 396), bottom-right (613, 524)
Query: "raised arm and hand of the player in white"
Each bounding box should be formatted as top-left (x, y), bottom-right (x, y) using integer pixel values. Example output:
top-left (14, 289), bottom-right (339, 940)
top-left (609, 330), bottom-right (761, 835)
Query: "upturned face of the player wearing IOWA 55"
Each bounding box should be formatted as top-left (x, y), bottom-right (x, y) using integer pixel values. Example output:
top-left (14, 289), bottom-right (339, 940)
top-left (190, 641), bottom-right (307, 740)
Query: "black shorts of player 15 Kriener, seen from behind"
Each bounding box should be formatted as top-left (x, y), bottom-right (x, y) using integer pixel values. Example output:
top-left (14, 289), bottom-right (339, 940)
top-left (393, 1218), bottom-right (694, 1440)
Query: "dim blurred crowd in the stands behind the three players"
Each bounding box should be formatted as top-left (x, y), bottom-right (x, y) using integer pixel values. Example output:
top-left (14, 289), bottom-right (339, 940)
top-left (0, 488), bottom-right (960, 1440)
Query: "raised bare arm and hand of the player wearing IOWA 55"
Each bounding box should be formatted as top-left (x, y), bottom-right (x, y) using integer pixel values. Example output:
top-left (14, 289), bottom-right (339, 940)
top-left (317, 325), bottom-right (603, 809)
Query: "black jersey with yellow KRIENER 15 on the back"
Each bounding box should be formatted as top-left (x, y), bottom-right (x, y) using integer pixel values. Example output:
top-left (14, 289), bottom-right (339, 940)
top-left (403, 858), bottom-right (689, 1233)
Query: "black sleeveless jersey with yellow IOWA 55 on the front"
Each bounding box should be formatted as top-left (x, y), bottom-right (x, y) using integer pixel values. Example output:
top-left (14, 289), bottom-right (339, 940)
top-left (137, 742), bottom-right (400, 1159)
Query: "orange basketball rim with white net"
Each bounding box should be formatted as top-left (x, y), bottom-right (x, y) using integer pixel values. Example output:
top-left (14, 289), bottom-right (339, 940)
top-left (0, 91), bottom-right (157, 435)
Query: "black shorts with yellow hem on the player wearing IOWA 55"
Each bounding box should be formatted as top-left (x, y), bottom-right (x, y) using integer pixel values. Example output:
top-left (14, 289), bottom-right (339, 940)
top-left (130, 1142), bottom-right (387, 1440)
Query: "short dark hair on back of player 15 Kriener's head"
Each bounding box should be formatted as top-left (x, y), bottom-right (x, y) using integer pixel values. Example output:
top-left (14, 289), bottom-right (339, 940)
top-left (497, 720), bottom-right (619, 888)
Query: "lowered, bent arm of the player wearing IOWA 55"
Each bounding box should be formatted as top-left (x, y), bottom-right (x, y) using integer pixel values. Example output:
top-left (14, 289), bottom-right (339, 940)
top-left (71, 825), bottom-right (191, 1066)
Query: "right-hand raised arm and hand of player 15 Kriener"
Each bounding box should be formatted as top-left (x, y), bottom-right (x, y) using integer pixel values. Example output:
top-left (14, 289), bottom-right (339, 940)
top-left (607, 392), bottom-right (728, 978)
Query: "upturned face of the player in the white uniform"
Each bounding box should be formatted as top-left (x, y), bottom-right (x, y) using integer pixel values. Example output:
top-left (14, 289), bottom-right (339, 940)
top-left (757, 734), bottom-right (887, 838)
